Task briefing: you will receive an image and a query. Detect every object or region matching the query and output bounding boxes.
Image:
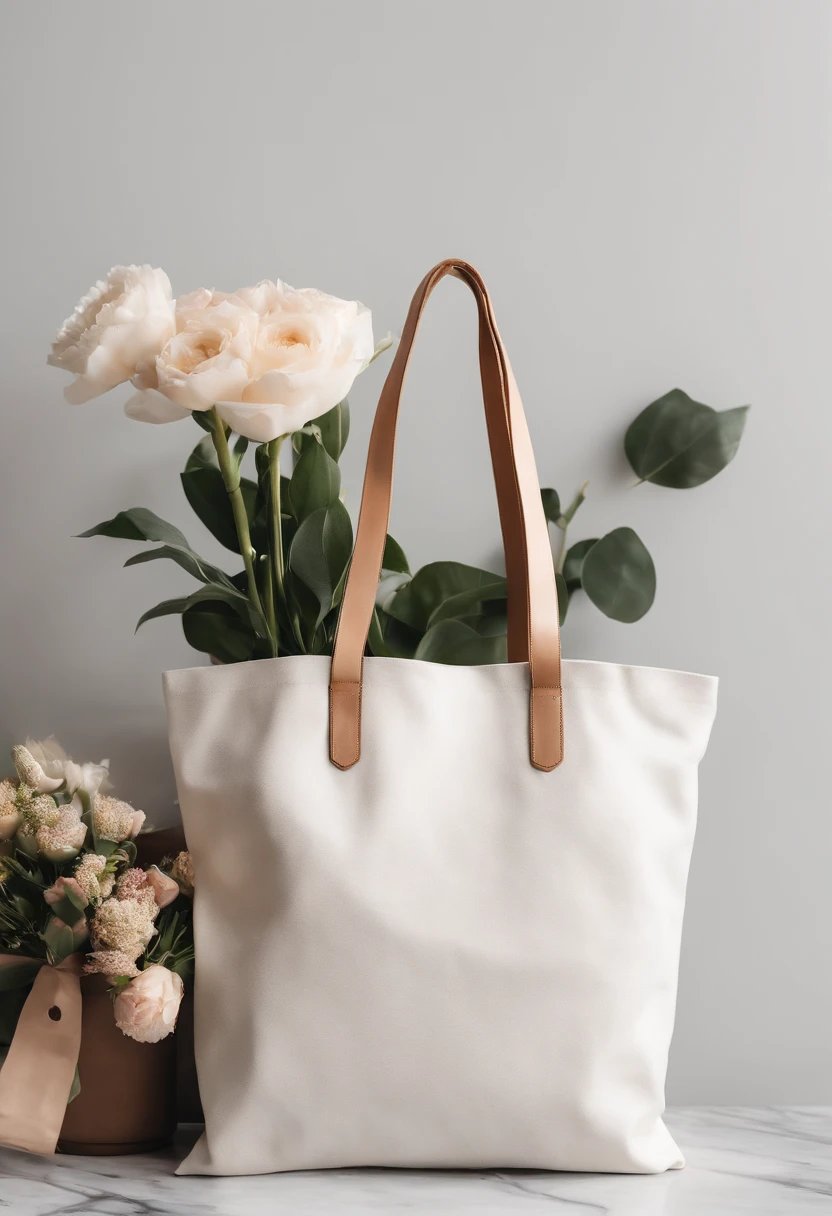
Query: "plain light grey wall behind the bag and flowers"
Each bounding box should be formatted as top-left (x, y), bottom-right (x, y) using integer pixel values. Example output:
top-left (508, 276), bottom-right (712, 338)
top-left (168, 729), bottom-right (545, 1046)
top-left (0, 0), bottom-right (832, 1103)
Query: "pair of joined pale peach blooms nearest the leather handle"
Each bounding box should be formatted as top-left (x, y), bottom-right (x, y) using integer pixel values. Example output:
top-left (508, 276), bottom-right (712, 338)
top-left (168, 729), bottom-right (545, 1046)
top-left (125, 280), bottom-right (377, 443)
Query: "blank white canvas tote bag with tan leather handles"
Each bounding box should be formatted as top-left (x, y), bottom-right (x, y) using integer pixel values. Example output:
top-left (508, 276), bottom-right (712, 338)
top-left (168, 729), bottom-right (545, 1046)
top-left (165, 261), bottom-right (716, 1175)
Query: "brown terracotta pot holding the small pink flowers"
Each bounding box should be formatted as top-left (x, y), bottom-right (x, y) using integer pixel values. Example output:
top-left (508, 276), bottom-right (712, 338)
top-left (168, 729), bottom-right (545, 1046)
top-left (57, 975), bottom-right (176, 1156)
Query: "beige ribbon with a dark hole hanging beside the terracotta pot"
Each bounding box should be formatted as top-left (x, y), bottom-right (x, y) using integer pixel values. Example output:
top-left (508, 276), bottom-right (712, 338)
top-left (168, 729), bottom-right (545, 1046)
top-left (0, 955), bottom-right (84, 1153)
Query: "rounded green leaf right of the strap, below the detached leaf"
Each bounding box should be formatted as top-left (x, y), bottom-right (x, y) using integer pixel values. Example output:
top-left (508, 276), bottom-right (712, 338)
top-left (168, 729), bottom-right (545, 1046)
top-left (581, 528), bottom-right (656, 624)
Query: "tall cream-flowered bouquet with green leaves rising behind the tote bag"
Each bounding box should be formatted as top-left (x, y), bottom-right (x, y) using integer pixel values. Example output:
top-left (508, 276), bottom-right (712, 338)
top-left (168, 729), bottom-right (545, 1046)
top-left (49, 266), bottom-right (748, 664)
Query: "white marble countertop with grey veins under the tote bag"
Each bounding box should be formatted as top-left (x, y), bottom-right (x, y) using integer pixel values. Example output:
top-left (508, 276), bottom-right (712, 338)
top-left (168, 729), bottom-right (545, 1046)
top-left (0, 1107), bottom-right (832, 1216)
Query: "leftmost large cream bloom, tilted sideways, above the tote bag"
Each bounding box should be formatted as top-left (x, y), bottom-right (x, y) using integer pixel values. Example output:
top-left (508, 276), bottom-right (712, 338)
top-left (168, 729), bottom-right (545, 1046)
top-left (46, 266), bottom-right (174, 405)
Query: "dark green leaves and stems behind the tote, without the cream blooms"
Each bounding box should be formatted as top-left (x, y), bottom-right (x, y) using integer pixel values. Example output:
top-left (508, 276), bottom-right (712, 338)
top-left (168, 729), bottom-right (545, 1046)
top-left (81, 389), bottom-right (748, 664)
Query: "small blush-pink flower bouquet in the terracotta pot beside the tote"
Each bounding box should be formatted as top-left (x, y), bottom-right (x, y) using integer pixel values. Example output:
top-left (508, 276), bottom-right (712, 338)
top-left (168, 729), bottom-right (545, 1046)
top-left (0, 739), bottom-right (193, 1065)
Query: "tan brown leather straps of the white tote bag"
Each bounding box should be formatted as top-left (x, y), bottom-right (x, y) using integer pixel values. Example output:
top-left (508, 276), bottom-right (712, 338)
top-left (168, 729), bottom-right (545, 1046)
top-left (330, 259), bottom-right (563, 771)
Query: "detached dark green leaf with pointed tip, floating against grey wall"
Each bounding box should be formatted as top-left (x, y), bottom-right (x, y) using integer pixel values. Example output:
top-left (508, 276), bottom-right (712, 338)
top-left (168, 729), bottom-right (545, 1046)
top-left (624, 388), bottom-right (748, 490)
